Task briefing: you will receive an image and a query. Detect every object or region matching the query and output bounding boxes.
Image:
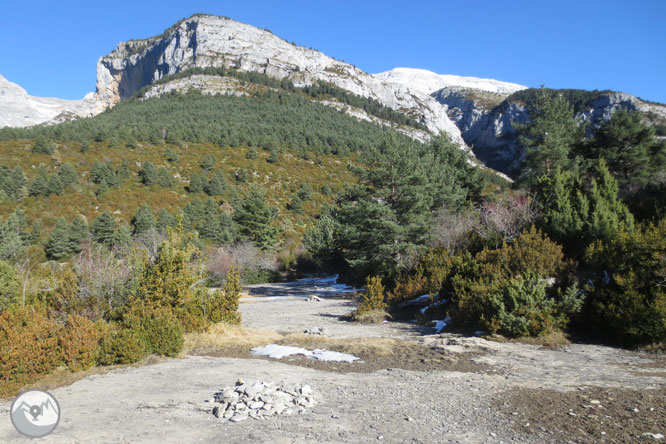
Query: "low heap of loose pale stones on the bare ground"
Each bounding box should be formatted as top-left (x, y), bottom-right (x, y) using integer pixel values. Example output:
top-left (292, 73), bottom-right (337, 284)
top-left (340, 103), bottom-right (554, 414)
top-left (211, 379), bottom-right (315, 422)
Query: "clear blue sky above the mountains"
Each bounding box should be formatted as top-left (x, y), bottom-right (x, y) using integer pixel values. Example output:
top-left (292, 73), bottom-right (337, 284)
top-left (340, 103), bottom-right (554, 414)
top-left (0, 0), bottom-right (666, 103)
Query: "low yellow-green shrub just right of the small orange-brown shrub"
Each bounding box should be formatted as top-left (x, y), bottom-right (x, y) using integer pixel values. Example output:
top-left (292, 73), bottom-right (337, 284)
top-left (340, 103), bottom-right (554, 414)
top-left (97, 322), bottom-right (147, 365)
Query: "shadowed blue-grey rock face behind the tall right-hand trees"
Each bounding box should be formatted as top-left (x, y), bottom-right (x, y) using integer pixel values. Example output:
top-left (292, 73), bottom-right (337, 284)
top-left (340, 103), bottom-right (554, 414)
top-left (433, 87), bottom-right (666, 175)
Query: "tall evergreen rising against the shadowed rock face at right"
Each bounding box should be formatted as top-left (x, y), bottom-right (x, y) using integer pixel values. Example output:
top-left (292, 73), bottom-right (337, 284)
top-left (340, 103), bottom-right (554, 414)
top-left (516, 91), bottom-right (585, 183)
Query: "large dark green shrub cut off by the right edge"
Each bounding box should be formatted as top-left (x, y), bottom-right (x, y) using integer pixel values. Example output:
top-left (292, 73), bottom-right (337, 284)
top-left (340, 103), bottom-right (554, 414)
top-left (584, 219), bottom-right (666, 345)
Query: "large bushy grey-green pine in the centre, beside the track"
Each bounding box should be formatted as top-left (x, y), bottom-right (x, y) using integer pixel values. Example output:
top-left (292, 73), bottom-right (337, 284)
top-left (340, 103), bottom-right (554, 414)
top-left (320, 136), bottom-right (478, 283)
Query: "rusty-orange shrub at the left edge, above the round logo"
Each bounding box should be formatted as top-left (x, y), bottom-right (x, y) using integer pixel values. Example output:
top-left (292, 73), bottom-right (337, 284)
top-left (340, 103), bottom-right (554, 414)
top-left (0, 306), bottom-right (61, 397)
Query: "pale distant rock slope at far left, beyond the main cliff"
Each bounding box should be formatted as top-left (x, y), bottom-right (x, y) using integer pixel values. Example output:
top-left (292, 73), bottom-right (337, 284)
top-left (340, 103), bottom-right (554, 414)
top-left (0, 75), bottom-right (104, 128)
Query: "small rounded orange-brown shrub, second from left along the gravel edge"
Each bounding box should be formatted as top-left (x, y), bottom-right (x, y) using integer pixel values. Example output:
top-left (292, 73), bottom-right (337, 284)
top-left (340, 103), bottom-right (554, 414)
top-left (58, 314), bottom-right (100, 371)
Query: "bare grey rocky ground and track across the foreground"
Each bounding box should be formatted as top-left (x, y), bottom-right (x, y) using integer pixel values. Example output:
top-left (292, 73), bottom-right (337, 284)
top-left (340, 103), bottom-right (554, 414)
top-left (0, 281), bottom-right (666, 444)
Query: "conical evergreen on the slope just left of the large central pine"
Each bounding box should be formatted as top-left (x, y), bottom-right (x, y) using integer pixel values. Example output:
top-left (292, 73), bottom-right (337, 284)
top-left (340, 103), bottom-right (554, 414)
top-left (234, 185), bottom-right (278, 249)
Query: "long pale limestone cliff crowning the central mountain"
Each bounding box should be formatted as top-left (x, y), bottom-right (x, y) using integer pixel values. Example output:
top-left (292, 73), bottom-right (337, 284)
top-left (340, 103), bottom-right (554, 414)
top-left (97, 15), bottom-right (523, 144)
